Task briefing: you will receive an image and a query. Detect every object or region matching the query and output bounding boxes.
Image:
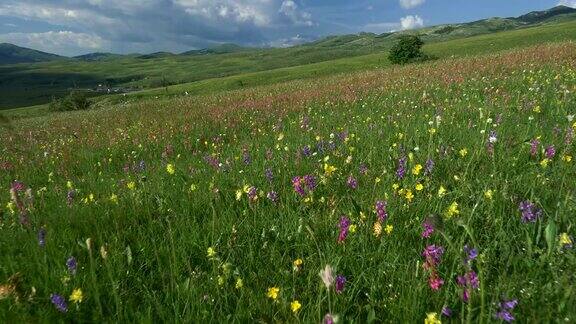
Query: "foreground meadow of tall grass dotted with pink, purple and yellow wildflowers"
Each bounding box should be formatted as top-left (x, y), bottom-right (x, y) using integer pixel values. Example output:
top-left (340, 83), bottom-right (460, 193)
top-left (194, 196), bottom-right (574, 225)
top-left (0, 42), bottom-right (576, 323)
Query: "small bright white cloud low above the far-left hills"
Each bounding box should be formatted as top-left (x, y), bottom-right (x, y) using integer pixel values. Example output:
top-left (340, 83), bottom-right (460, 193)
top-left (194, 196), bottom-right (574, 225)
top-left (0, 31), bottom-right (109, 54)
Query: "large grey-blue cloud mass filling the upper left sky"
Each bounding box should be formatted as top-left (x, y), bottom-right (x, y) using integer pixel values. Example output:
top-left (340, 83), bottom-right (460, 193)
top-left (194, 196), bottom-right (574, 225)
top-left (0, 0), bottom-right (316, 55)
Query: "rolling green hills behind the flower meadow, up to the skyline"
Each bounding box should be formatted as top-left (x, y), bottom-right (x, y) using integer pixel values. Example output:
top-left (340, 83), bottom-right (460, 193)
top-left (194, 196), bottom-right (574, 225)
top-left (0, 6), bottom-right (576, 109)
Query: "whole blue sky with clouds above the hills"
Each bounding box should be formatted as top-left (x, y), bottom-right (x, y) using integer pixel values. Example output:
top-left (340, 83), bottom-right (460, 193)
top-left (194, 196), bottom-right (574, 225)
top-left (0, 0), bottom-right (576, 56)
